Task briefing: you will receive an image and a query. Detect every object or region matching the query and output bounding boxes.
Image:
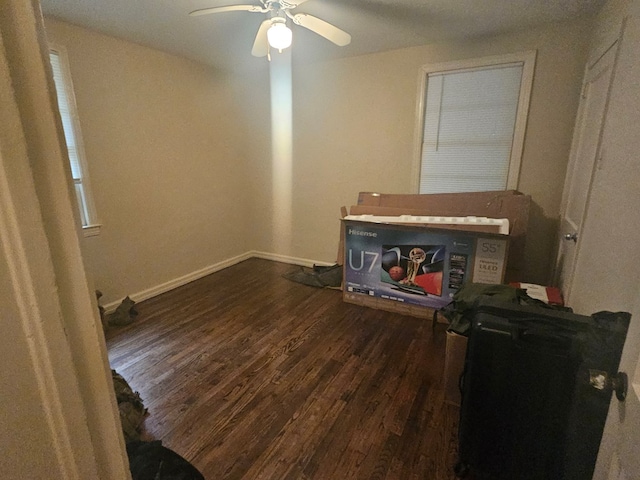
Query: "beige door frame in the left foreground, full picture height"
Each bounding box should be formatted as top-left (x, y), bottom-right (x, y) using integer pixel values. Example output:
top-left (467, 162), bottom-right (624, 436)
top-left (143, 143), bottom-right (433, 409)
top-left (0, 0), bottom-right (131, 480)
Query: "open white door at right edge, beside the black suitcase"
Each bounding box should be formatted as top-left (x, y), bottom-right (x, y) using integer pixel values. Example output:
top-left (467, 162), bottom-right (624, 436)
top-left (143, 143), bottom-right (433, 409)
top-left (571, 0), bottom-right (640, 480)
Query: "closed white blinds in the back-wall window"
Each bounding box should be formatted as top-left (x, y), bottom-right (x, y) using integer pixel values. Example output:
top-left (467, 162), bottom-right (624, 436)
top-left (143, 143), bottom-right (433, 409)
top-left (420, 62), bottom-right (523, 193)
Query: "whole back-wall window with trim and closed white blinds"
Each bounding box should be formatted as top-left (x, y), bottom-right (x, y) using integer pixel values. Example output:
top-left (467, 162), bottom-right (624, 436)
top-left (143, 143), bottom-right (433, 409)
top-left (415, 52), bottom-right (535, 193)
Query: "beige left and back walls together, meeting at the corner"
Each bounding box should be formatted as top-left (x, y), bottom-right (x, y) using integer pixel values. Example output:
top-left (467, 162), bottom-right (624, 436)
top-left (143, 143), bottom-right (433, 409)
top-left (46, 15), bottom-right (590, 302)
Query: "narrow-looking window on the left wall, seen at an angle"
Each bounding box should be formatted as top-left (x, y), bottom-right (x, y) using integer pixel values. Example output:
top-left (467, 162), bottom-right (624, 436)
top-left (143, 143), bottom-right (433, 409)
top-left (49, 47), bottom-right (100, 236)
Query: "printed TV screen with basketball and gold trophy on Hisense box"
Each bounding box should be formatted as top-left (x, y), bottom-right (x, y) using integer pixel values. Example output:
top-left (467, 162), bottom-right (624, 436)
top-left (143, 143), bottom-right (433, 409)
top-left (380, 245), bottom-right (447, 297)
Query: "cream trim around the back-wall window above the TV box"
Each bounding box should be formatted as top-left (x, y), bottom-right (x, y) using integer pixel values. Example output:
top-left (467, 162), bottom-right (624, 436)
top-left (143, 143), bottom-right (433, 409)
top-left (411, 50), bottom-right (537, 193)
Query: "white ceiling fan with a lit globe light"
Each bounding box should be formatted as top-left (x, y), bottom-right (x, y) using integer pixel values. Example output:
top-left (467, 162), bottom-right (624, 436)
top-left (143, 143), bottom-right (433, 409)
top-left (189, 0), bottom-right (351, 57)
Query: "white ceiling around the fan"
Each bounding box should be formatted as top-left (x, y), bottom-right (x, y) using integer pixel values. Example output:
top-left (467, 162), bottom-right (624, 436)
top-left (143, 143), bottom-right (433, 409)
top-left (41, 0), bottom-right (605, 70)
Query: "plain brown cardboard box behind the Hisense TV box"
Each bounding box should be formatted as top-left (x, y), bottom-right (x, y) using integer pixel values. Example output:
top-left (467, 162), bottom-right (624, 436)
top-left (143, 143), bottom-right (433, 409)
top-left (348, 190), bottom-right (531, 282)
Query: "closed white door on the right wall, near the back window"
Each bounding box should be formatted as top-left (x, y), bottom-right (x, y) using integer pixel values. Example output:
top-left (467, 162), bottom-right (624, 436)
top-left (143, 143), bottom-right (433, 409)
top-left (556, 41), bottom-right (618, 304)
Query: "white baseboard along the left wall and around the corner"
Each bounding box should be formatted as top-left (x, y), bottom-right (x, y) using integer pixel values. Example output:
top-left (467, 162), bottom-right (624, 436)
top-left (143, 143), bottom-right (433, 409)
top-left (103, 250), bottom-right (333, 313)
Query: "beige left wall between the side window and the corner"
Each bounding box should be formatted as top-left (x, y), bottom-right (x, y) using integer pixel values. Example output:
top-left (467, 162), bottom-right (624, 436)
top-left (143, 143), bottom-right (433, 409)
top-left (46, 20), bottom-right (250, 303)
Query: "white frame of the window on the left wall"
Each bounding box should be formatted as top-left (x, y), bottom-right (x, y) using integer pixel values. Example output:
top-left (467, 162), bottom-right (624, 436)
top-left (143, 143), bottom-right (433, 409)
top-left (48, 44), bottom-right (102, 237)
